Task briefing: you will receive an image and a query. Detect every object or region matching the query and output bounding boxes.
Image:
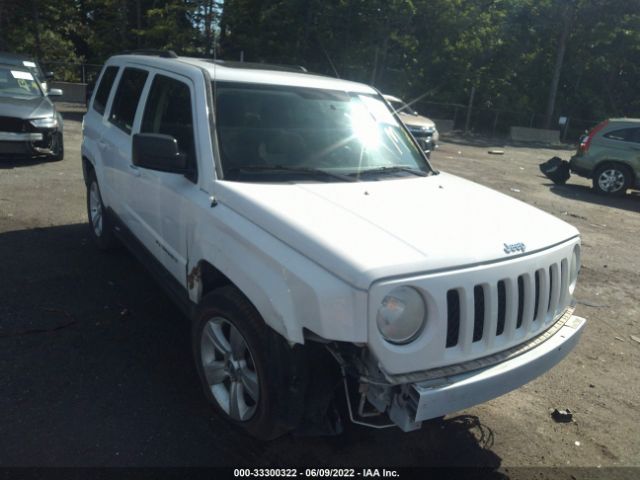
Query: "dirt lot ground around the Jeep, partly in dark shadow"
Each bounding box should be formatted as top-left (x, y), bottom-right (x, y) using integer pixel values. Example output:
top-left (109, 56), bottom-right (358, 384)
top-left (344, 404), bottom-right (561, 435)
top-left (0, 113), bottom-right (640, 478)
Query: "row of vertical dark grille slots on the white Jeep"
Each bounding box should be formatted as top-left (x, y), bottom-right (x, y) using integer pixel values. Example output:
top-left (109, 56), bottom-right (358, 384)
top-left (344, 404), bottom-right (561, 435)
top-left (446, 259), bottom-right (569, 350)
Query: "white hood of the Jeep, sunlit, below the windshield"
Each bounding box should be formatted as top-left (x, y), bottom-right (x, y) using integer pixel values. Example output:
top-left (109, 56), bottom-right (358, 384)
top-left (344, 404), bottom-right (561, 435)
top-left (217, 173), bottom-right (578, 289)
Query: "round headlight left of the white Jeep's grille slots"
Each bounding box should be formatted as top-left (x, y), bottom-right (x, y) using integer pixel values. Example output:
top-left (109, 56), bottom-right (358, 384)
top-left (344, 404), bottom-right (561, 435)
top-left (376, 286), bottom-right (427, 345)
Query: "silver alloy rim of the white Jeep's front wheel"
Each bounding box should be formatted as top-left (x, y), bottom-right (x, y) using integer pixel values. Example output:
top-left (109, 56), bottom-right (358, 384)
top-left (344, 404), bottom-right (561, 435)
top-left (200, 317), bottom-right (260, 422)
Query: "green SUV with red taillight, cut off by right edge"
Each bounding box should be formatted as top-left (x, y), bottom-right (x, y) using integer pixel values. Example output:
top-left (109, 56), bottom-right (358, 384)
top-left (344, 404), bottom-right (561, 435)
top-left (569, 118), bottom-right (640, 195)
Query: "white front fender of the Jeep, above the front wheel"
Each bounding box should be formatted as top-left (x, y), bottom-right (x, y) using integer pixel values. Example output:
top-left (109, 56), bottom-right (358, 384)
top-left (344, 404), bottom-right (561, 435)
top-left (187, 205), bottom-right (367, 343)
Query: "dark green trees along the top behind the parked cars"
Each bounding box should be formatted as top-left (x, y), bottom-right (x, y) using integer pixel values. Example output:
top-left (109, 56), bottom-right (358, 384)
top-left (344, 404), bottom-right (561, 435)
top-left (0, 0), bottom-right (640, 126)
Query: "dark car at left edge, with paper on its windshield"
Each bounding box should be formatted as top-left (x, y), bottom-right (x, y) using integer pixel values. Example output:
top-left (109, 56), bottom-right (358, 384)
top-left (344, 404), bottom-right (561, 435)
top-left (0, 64), bottom-right (64, 160)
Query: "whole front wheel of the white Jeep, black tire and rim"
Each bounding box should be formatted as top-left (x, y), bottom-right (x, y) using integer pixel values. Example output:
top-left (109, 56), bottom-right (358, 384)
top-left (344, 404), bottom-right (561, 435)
top-left (192, 286), bottom-right (305, 440)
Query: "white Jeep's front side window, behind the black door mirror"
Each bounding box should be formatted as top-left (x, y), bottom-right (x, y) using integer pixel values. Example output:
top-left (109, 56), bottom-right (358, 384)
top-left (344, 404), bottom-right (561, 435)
top-left (140, 75), bottom-right (196, 170)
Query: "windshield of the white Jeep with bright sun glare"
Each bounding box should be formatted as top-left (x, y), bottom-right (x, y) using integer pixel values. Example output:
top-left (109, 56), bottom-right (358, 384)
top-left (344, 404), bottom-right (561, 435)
top-left (215, 82), bottom-right (431, 181)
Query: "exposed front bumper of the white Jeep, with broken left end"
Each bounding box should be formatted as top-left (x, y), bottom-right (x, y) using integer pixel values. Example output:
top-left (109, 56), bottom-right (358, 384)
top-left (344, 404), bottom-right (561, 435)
top-left (342, 309), bottom-right (586, 431)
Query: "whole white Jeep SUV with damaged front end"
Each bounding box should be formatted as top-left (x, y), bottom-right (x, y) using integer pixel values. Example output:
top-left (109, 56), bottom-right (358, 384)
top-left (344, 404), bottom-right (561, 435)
top-left (82, 52), bottom-right (585, 439)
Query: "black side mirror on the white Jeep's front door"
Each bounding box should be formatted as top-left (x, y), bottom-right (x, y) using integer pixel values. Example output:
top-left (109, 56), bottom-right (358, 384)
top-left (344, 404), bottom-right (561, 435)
top-left (131, 133), bottom-right (189, 174)
